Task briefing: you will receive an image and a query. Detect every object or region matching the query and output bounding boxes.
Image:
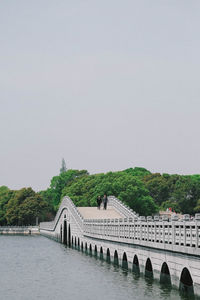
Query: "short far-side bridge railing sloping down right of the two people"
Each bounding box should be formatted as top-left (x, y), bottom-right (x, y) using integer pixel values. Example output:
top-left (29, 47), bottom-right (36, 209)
top-left (108, 196), bottom-right (137, 218)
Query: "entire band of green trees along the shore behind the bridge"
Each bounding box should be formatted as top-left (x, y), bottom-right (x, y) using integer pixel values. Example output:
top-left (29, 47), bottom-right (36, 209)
top-left (0, 163), bottom-right (200, 225)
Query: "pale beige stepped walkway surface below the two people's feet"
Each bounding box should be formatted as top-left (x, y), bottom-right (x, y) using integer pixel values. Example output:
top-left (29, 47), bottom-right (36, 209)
top-left (77, 206), bottom-right (124, 219)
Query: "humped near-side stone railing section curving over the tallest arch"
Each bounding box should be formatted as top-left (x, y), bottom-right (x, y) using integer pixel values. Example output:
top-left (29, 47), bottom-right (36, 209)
top-left (40, 196), bottom-right (83, 231)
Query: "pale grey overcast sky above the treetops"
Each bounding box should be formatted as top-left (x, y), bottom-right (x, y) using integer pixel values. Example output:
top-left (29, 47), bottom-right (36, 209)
top-left (0, 0), bottom-right (200, 190)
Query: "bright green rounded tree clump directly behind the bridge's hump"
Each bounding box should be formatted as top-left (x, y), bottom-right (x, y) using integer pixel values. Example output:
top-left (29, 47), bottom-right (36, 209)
top-left (62, 171), bottom-right (158, 215)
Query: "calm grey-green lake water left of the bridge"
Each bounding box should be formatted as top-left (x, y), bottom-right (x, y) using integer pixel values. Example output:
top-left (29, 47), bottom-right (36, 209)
top-left (0, 236), bottom-right (197, 300)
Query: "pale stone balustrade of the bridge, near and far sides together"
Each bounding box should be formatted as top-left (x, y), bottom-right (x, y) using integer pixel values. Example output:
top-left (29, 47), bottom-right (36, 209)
top-left (40, 196), bottom-right (200, 255)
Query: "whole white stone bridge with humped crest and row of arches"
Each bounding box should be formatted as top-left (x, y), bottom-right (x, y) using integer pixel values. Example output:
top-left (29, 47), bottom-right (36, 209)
top-left (40, 196), bottom-right (200, 295)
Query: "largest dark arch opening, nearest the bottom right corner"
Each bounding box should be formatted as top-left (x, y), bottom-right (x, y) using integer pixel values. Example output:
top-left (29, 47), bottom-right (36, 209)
top-left (179, 268), bottom-right (194, 296)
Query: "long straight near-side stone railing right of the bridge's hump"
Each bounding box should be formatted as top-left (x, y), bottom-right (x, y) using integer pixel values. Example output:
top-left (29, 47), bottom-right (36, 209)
top-left (84, 217), bottom-right (200, 254)
